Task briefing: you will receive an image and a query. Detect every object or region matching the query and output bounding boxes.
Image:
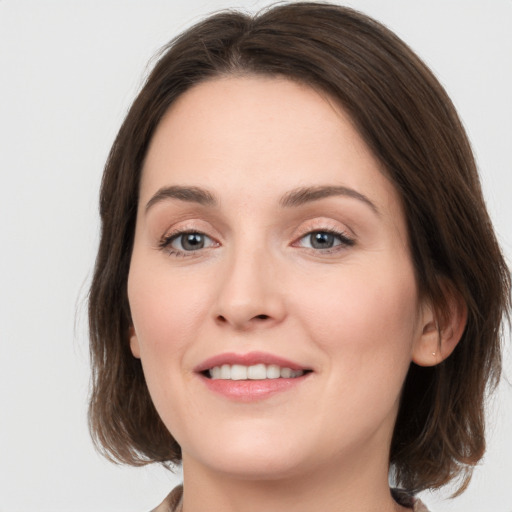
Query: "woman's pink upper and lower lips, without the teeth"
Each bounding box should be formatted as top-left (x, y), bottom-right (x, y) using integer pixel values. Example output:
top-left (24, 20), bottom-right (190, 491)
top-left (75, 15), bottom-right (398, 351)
top-left (195, 352), bottom-right (311, 402)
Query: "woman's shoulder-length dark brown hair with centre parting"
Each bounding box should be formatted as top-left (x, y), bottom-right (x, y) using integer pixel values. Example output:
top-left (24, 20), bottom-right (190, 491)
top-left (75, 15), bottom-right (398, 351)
top-left (89, 2), bottom-right (510, 492)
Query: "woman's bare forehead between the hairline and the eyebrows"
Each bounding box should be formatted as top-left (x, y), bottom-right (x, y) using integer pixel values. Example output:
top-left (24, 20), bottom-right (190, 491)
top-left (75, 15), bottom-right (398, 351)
top-left (141, 76), bottom-right (399, 220)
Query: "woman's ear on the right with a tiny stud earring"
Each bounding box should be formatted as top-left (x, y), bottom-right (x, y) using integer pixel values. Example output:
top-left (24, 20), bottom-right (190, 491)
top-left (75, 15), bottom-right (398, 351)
top-left (412, 283), bottom-right (468, 366)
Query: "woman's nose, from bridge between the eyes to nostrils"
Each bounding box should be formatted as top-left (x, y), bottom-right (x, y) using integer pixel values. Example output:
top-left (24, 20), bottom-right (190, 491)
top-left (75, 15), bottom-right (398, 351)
top-left (215, 242), bottom-right (286, 331)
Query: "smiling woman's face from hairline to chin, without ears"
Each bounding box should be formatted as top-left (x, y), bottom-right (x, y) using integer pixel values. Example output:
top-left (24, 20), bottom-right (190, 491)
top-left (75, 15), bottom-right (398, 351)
top-left (128, 77), bottom-right (424, 478)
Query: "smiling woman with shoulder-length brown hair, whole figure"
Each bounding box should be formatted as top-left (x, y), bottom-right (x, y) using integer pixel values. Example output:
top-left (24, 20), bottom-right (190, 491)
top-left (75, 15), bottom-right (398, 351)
top-left (90, 3), bottom-right (510, 512)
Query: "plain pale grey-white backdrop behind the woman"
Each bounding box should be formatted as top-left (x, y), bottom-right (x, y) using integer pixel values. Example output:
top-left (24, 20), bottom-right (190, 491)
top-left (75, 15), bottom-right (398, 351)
top-left (0, 0), bottom-right (512, 512)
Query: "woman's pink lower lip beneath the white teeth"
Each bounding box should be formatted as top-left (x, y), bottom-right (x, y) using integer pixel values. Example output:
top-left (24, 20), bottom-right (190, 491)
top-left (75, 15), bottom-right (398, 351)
top-left (201, 373), bottom-right (310, 402)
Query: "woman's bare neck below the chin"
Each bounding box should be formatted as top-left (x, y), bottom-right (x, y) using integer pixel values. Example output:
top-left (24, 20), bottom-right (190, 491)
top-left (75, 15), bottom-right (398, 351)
top-left (183, 444), bottom-right (410, 512)
